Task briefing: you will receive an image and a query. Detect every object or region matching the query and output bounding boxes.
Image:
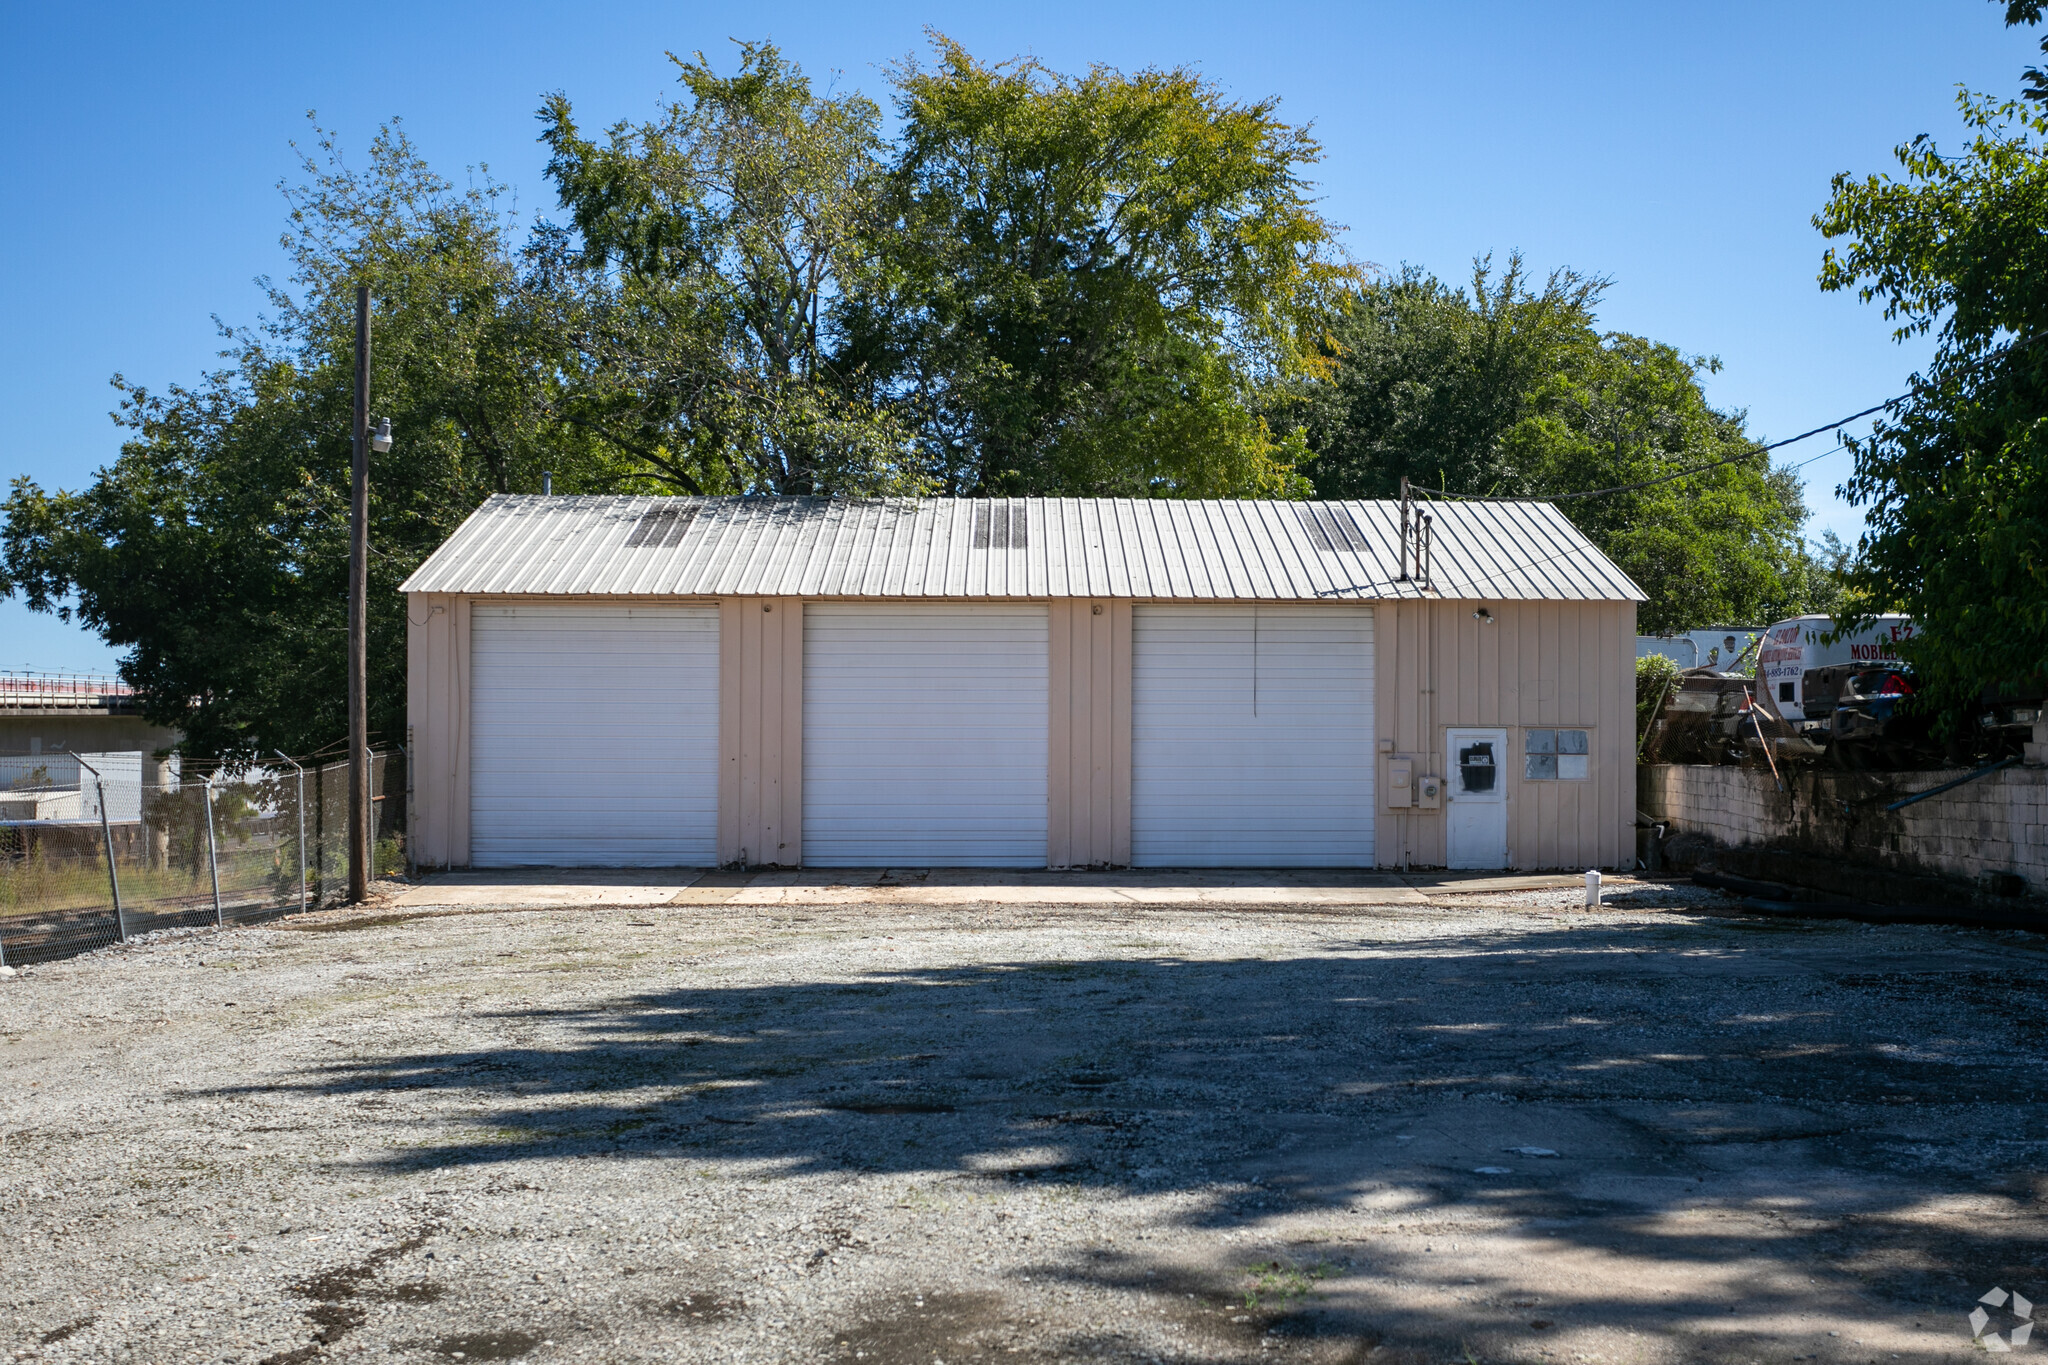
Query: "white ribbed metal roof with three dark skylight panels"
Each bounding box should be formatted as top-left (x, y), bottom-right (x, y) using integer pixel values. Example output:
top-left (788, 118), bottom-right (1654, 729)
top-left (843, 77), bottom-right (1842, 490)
top-left (401, 493), bottom-right (1645, 602)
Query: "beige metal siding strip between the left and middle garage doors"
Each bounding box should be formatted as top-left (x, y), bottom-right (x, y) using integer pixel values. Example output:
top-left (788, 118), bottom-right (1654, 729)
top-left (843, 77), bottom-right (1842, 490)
top-left (719, 598), bottom-right (803, 868)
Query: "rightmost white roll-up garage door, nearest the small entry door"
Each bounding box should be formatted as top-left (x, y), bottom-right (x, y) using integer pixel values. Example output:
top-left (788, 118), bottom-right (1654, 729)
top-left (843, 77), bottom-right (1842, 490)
top-left (1130, 604), bottom-right (1374, 868)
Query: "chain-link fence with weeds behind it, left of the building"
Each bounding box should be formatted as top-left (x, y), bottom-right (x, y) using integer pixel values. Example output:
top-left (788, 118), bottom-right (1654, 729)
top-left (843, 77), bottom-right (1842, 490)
top-left (0, 753), bottom-right (406, 966)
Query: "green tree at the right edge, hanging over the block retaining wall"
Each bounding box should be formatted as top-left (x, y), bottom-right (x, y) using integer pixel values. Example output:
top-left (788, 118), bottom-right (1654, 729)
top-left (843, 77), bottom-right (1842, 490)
top-left (1815, 69), bottom-right (2048, 698)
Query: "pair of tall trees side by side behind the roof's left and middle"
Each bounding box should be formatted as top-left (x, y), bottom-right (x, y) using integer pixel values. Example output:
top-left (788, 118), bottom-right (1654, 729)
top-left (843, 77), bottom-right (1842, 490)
top-left (543, 35), bottom-right (1352, 497)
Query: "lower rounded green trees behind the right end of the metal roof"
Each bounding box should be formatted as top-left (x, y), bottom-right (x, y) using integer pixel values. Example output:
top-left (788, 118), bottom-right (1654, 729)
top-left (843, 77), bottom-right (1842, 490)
top-left (1284, 258), bottom-right (1837, 630)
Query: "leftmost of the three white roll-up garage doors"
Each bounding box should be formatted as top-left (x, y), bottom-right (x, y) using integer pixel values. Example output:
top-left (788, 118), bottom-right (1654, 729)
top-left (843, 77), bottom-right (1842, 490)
top-left (469, 604), bottom-right (719, 868)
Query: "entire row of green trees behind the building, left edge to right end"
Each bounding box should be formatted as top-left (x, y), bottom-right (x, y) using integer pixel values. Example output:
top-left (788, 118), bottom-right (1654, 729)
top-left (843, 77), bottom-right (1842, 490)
top-left (0, 35), bottom-right (1851, 761)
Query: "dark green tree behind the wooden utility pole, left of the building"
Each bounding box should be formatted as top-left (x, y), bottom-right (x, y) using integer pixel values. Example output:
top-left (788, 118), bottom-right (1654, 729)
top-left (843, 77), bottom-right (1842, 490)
top-left (0, 127), bottom-right (637, 761)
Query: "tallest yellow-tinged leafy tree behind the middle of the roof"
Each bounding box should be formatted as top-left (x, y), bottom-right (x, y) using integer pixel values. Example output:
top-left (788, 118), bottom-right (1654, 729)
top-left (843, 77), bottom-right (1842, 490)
top-left (846, 35), bottom-right (1350, 497)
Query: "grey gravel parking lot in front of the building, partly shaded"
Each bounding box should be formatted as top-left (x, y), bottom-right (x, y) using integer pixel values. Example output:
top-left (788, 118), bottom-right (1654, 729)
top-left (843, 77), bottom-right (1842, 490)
top-left (0, 884), bottom-right (2048, 1365)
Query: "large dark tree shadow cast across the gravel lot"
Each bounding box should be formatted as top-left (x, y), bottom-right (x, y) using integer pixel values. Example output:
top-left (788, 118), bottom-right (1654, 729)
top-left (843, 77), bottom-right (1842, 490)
top-left (203, 923), bottom-right (2048, 1361)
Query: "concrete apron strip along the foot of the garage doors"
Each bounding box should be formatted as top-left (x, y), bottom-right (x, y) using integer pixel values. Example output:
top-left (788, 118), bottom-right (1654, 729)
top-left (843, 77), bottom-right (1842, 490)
top-left (385, 868), bottom-right (1585, 909)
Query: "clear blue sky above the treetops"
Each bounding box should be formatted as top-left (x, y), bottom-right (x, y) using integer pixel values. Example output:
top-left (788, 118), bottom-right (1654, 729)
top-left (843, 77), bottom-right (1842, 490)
top-left (0, 0), bottom-right (2034, 669)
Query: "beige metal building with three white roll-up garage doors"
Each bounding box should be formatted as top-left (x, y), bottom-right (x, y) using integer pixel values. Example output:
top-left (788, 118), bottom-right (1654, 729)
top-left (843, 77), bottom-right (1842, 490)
top-left (403, 495), bottom-right (1642, 868)
